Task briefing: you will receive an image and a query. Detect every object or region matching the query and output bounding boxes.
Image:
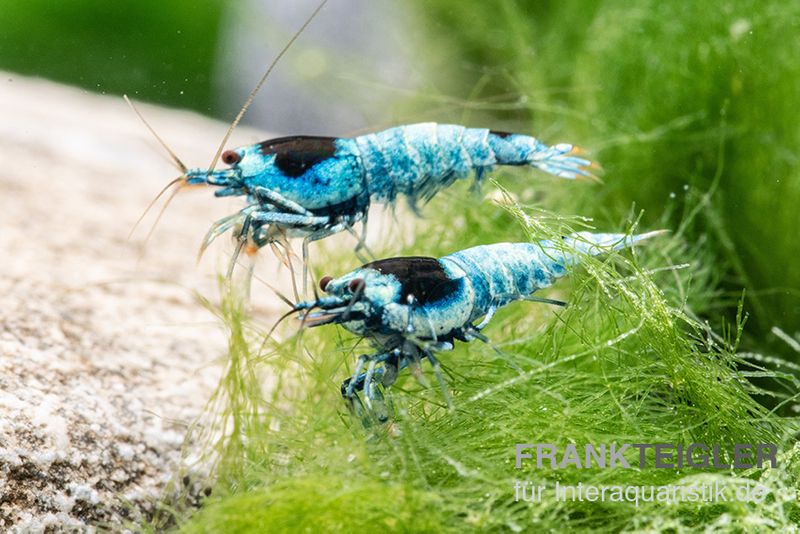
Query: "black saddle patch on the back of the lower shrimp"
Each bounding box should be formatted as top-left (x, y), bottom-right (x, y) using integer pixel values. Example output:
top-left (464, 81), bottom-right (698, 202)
top-left (364, 256), bottom-right (463, 305)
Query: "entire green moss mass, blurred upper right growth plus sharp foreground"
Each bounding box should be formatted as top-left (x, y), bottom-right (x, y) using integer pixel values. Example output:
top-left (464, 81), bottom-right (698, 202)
top-left (145, 0), bottom-right (800, 532)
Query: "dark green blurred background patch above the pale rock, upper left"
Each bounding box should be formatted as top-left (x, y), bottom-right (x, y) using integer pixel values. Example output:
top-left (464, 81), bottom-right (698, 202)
top-left (0, 0), bottom-right (224, 114)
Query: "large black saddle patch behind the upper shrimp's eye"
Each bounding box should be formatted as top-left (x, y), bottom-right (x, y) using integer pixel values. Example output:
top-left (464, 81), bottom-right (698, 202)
top-left (259, 135), bottom-right (336, 178)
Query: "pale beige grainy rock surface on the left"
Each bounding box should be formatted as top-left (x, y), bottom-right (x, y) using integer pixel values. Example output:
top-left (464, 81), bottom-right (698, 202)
top-left (0, 73), bottom-right (288, 532)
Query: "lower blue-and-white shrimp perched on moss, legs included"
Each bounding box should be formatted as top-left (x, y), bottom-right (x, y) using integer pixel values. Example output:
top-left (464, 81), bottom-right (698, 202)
top-left (290, 231), bottom-right (662, 420)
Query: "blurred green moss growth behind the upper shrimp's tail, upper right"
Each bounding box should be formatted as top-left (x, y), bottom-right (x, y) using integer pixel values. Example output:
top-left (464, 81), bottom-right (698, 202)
top-left (406, 0), bottom-right (800, 364)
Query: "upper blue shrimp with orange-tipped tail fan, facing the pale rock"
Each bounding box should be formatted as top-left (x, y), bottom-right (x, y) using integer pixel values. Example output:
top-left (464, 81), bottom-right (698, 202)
top-left (185, 123), bottom-right (596, 266)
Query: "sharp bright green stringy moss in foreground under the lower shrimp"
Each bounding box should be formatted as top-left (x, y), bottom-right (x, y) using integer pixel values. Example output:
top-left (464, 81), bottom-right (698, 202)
top-left (166, 200), bottom-right (800, 532)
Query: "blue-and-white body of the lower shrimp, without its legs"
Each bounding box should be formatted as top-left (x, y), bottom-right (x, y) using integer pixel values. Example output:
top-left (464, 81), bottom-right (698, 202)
top-left (299, 232), bottom-right (653, 350)
